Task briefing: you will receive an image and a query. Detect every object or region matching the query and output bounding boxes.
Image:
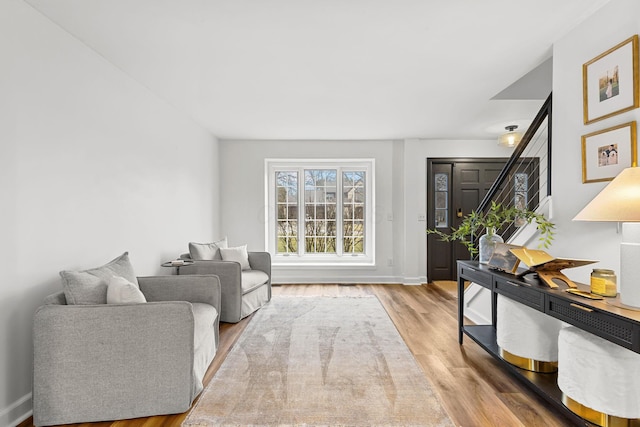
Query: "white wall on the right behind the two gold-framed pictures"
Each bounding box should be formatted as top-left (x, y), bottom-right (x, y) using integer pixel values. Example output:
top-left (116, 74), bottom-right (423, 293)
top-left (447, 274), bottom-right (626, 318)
top-left (551, 0), bottom-right (640, 283)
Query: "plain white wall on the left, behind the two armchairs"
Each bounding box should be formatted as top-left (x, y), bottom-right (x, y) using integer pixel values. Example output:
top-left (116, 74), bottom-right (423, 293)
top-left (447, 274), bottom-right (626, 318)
top-left (0, 0), bottom-right (218, 426)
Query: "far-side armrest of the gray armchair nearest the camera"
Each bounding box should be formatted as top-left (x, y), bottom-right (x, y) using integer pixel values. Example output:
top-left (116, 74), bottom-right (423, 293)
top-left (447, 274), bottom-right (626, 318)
top-left (138, 274), bottom-right (221, 313)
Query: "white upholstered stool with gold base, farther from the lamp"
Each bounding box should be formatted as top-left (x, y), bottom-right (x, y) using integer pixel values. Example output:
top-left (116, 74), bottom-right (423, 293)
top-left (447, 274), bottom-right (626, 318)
top-left (496, 294), bottom-right (562, 373)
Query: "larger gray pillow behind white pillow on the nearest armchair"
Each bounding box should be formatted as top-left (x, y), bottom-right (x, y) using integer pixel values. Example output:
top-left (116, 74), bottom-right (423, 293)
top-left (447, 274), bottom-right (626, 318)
top-left (60, 252), bottom-right (138, 304)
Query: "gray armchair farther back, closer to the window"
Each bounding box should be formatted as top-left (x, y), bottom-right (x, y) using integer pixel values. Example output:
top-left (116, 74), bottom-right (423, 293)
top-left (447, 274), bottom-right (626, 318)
top-left (178, 252), bottom-right (271, 323)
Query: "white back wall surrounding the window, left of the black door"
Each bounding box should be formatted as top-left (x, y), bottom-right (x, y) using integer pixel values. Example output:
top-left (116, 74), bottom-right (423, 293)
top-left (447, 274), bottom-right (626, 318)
top-left (220, 140), bottom-right (511, 283)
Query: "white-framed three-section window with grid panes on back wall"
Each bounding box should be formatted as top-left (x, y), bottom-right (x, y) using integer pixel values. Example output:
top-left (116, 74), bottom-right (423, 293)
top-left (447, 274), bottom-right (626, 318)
top-left (266, 159), bottom-right (374, 265)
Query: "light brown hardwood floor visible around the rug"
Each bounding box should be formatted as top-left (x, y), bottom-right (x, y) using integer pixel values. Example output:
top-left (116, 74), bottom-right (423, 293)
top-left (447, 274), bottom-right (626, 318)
top-left (19, 282), bottom-right (572, 427)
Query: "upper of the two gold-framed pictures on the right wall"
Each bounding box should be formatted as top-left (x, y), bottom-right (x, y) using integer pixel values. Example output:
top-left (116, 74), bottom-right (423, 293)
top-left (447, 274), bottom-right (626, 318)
top-left (582, 34), bottom-right (640, 124)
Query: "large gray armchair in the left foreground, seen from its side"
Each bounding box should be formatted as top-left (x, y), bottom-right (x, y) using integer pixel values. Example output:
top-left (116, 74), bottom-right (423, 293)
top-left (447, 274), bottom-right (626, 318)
top-left (33, 275), bottom-right (220, 426)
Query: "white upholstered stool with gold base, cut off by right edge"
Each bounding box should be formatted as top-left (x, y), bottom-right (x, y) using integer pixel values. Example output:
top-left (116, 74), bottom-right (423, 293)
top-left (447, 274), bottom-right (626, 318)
top-left (558, 326), bottom-right (640, 426)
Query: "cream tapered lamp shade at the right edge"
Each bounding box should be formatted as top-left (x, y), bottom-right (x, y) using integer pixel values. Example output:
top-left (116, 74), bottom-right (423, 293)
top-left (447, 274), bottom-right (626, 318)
top-left (573, 167), bottom-right (640, 222)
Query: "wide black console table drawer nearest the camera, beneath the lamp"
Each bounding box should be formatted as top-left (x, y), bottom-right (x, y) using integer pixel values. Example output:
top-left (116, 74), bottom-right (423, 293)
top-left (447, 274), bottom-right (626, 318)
top-left (547, 295), bottom-right (633, 349)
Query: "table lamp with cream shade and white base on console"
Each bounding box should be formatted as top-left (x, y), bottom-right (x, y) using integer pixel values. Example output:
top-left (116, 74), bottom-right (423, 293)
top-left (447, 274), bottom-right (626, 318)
top-left (573, 167), bottom-right (640, 308)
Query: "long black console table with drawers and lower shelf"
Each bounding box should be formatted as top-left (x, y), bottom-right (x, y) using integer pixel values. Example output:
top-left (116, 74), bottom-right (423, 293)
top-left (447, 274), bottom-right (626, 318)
top-left (458, 261), bottom-right (640, 425)
